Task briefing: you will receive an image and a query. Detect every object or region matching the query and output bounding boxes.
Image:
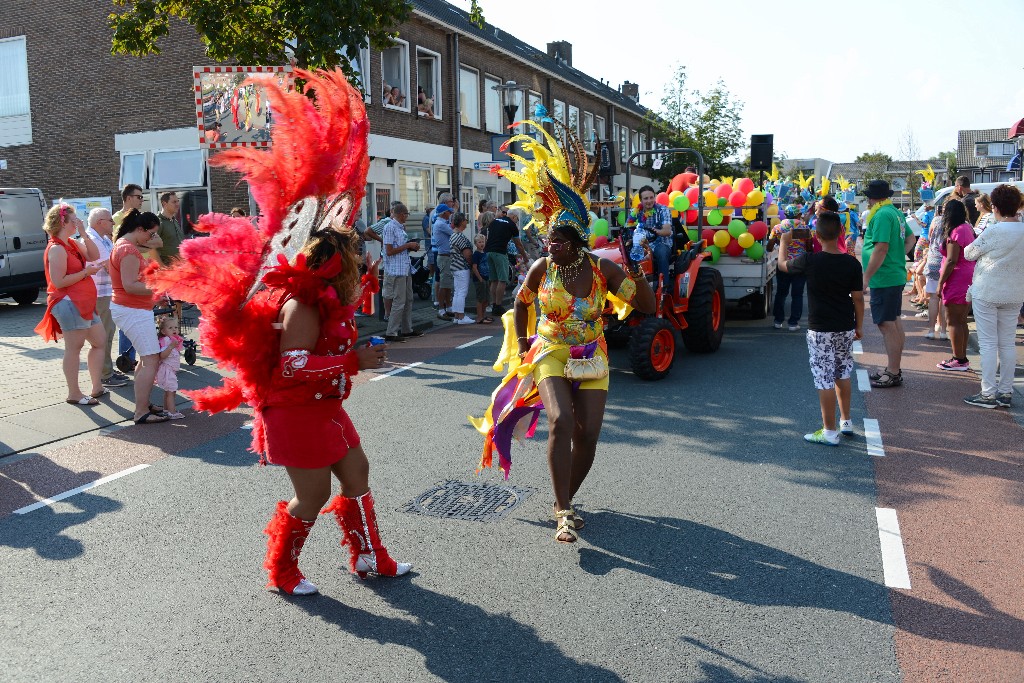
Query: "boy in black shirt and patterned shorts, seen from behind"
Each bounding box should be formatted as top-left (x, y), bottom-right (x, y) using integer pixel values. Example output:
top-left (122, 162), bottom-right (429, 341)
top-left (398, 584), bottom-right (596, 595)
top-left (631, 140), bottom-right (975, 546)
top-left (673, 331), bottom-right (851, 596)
top-left (778, 211), bottom-right (864, 445)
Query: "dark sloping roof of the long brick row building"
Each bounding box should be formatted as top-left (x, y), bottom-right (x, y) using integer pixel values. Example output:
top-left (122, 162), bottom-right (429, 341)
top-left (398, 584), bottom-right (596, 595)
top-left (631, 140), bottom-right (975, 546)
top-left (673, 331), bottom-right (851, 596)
top-left (412, 0), bottom-right (648, 117)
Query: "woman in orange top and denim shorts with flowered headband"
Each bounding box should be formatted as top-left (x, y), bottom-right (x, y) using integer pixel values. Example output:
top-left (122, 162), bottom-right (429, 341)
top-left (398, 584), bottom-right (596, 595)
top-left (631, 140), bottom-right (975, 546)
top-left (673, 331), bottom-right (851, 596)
top-left (36, 203), bottom-right (106, 405)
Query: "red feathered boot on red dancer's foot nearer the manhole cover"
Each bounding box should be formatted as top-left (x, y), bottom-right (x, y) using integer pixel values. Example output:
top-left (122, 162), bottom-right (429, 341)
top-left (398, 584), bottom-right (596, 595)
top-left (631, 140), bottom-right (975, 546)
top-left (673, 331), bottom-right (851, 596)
top-left (321, 490), bottom-right (413, 579)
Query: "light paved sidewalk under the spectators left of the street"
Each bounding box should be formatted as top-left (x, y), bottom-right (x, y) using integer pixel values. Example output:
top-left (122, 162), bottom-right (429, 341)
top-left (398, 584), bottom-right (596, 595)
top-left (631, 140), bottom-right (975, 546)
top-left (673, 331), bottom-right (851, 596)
top-left (0, 290), bottom-right (452, 458)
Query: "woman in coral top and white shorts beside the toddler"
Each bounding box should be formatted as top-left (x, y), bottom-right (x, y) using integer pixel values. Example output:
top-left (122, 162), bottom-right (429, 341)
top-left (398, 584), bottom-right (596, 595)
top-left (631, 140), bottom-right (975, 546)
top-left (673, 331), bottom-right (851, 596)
top-left (110, 209), bottom-right (167, 425)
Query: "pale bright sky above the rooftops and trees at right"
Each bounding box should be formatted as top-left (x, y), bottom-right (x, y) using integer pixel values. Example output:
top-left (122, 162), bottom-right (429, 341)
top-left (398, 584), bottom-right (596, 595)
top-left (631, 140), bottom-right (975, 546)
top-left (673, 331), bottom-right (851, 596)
top-left (460, 0), bottom-right (1024, 162)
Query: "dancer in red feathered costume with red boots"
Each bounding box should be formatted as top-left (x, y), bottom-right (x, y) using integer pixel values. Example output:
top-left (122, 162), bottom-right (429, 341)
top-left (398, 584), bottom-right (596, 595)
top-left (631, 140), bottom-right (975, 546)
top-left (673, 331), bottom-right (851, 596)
top-left (148, 70), bottom-right (412, 595)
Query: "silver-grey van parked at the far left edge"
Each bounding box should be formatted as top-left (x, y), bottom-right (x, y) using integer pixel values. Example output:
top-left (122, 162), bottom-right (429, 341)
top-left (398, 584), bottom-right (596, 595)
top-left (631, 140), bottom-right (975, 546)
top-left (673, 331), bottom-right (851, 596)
top-left (0, 187), bottom-right (47, 306)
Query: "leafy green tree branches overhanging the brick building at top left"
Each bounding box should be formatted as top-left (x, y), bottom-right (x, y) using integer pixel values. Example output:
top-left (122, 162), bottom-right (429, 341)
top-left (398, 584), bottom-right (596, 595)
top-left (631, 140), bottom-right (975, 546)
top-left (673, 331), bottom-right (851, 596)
top-left (109, 0), bottom-right (483, 78)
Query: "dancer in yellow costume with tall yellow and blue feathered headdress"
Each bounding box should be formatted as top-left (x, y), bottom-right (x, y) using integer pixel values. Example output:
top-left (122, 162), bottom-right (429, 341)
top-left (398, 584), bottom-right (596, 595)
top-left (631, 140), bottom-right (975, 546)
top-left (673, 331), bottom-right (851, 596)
top-left (472, 121), bottom-right (655, 543)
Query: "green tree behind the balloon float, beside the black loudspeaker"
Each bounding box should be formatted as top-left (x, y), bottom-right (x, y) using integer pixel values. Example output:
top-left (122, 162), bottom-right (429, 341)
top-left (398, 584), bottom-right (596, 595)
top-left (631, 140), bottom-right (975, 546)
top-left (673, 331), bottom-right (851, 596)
top-left (648, 65), bottom-right (743, 182)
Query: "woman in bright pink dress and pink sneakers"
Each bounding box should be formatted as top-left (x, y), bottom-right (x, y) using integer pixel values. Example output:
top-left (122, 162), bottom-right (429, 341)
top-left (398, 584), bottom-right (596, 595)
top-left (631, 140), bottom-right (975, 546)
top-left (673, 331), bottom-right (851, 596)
top-left (933, 200), bottom-right (975, 372)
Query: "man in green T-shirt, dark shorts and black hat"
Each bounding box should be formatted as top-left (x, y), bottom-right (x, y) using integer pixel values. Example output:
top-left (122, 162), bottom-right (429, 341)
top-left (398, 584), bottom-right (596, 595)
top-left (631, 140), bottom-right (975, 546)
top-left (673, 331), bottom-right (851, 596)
top-left (861, 180), bottom-right (906, 388)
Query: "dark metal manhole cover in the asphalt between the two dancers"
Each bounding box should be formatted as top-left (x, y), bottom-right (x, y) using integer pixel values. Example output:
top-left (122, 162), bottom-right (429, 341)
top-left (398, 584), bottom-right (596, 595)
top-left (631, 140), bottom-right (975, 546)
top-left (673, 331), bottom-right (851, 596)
top-left (401, 479), bottom-right (534, 522)
